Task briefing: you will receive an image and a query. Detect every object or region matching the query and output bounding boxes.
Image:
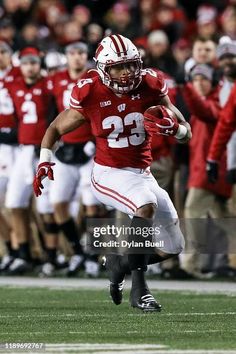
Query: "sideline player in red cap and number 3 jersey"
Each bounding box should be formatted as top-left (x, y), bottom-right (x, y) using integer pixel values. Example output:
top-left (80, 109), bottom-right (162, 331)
top-left (6, 47), bottom-right (57, 274)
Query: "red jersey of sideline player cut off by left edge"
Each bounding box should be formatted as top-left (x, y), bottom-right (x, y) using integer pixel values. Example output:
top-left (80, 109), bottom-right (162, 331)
top-left (0, 66), bottom-right (21, 129)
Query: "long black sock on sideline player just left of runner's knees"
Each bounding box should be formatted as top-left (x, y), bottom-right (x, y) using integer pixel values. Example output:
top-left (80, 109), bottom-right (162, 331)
top-left (59, 218), bottom-right (83, 254)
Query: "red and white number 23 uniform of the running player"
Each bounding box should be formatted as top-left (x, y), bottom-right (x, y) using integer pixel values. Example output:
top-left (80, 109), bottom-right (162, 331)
top-left (70, 69), bottom-right (183, 253)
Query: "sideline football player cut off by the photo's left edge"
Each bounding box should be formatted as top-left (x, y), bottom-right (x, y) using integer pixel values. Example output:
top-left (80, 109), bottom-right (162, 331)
top-left (0, 40), bottom-right (20, 271)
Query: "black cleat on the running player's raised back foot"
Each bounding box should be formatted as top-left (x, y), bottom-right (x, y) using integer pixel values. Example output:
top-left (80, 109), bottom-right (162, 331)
top-left (105, 254), bottom-right (129, 305)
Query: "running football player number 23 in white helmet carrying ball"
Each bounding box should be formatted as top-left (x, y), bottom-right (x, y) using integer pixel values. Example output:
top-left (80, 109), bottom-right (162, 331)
top-left (34, 34), bottom-right (191, 311)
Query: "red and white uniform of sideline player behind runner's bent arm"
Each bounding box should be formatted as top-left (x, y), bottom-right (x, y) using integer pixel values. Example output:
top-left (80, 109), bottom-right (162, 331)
top-left (49, 70), bottom-right (98, 206)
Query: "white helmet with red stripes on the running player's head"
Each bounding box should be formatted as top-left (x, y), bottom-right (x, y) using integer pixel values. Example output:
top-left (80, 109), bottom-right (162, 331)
top-left (94, 35), bottom-right (142, 94)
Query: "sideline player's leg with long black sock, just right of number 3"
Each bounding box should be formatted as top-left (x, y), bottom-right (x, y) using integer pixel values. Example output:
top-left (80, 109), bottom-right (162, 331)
top-left (50, 160), bottom-right (84, 276)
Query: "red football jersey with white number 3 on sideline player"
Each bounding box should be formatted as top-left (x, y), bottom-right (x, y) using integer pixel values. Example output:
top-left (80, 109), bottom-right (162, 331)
top-left (7, 77), bottom-right (51, 145)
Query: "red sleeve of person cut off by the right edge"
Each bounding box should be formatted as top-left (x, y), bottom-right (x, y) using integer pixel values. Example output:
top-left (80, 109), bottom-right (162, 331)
top-left (208, 85), bottom-right (236, 165)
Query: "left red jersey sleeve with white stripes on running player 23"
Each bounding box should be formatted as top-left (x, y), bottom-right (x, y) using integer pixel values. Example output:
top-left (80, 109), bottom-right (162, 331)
top-left (70, 78), bottom-right (93, 114)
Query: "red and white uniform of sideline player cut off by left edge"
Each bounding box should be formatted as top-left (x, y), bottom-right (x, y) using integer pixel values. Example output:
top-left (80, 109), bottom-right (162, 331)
top-left (0, 67), bottom-right (20, 206)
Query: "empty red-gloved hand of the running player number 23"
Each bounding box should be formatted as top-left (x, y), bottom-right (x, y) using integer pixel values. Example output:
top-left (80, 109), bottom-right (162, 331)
top-left (33, 162), bottom-right (55, 197)
